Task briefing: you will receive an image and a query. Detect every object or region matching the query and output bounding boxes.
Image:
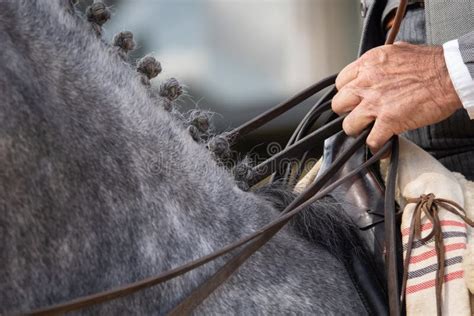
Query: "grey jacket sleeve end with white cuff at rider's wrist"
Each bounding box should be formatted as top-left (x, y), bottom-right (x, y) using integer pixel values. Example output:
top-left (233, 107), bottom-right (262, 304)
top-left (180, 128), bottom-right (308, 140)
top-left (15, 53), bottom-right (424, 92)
top-left (443, 31), bottom-right (474, 119)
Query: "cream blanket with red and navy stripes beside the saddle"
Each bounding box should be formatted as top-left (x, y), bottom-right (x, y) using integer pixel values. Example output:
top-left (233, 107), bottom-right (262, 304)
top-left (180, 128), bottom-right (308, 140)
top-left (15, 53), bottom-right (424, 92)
top-left (398, 138), bottom-right (474, 315)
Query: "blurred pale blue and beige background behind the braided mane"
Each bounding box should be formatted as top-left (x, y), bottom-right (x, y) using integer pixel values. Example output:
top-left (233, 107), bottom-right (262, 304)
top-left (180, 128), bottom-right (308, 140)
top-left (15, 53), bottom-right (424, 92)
top-left (84, 0), bottom-right (362, 150)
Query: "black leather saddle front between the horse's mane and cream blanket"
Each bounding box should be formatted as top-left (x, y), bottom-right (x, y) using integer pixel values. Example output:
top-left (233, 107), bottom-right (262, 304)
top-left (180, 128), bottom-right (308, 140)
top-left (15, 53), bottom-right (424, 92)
top-left (318, 133), bottom-right (402, 315)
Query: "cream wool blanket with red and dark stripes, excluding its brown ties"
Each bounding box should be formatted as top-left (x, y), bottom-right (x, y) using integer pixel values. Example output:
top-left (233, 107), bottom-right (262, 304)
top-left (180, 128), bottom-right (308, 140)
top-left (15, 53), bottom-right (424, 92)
top-left (390, 138), bottom-right (471, 316)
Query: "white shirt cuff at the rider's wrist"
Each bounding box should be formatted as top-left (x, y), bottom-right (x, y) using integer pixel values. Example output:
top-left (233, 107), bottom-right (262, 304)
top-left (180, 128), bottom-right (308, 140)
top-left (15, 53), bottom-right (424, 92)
top-left (443, 39), bottom-right (474, 120)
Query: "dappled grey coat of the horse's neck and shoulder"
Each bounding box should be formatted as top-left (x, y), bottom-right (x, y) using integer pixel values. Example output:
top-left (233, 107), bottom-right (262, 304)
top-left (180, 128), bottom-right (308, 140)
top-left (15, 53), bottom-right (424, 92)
top-left (0, 0), bottom-right (366, 315)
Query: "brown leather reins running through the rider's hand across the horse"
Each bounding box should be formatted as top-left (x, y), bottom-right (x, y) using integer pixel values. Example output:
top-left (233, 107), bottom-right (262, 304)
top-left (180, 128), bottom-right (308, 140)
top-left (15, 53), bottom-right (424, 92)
top-left (23, 0), bottom-right (407, 315)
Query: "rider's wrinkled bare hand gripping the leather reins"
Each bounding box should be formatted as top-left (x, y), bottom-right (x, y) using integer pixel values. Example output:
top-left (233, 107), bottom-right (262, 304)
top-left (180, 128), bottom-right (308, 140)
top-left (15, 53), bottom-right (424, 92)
top-left (332, 43), bottom-right (462, 152)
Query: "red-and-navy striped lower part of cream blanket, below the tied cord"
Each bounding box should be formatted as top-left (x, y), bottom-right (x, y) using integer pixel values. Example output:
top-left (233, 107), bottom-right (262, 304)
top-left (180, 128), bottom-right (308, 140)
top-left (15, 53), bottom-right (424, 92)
top-left (402, 204), bottom-right (469, 315)
